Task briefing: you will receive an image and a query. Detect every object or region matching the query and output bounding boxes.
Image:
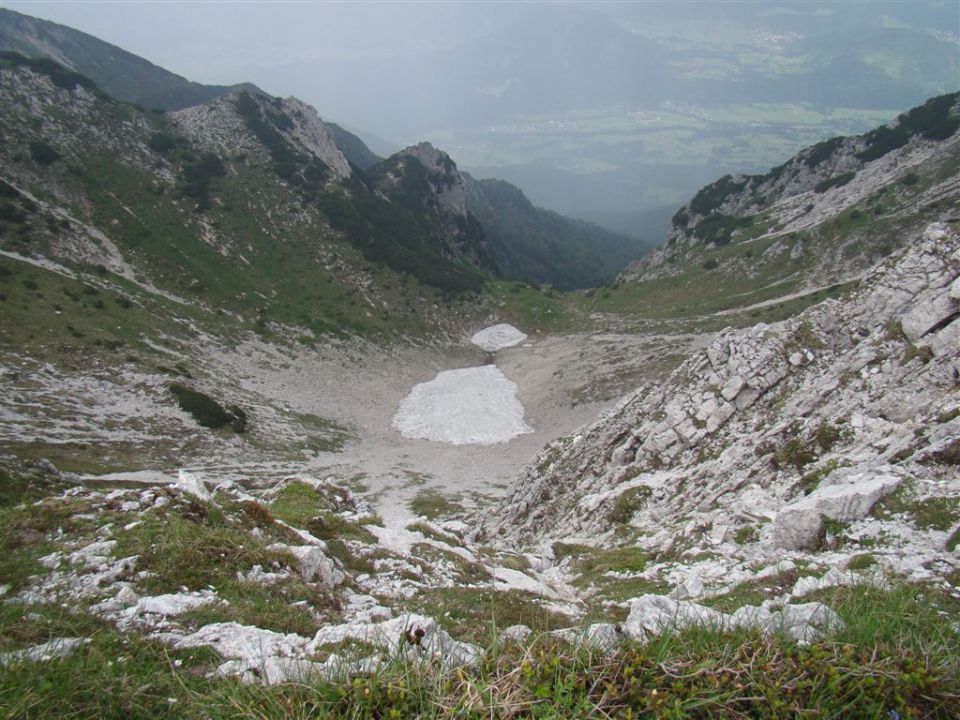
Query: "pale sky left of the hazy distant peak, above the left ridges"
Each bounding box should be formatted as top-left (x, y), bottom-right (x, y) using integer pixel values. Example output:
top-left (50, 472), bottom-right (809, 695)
top-left (0, 0), bottom-right (520, 82)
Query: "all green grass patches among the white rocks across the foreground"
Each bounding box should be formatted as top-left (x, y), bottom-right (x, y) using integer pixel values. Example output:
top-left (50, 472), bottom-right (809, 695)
top-left (0, 476), bottom-right (960, 720)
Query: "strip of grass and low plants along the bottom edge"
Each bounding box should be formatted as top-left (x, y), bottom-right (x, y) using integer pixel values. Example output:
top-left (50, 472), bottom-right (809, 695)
top-left (0, 606), bottom-right (960, 720)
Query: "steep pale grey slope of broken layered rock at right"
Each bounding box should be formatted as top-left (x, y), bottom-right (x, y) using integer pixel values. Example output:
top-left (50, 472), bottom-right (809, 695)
top-left (480, 224), bottom-right (960, 591)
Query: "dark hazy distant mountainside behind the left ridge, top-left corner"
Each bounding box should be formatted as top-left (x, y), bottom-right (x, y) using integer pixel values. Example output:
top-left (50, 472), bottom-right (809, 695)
top-left (0, 8), bottom-right (259, 110)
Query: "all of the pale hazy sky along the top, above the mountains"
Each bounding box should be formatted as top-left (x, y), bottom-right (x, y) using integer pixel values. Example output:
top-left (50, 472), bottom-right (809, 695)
top-left (0, 0), bottom-right (960, 94)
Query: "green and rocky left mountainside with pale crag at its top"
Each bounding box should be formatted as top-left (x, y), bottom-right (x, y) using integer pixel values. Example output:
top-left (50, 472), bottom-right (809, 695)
top-left (0, 53), bottom-right (492, 344)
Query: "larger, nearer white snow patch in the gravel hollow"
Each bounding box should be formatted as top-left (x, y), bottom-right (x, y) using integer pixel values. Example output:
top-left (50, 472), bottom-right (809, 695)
top-left (393, 366), bottom-right (533, 445)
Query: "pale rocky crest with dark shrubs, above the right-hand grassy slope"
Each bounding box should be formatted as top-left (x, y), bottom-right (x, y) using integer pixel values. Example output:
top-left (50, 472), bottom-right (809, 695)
top-left (619, 94), bottom-right (960, 282)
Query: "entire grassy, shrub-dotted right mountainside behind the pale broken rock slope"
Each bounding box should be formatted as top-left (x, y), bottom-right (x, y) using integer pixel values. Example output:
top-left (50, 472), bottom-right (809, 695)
top-left (588, 94), bottom-right (960, 330)
